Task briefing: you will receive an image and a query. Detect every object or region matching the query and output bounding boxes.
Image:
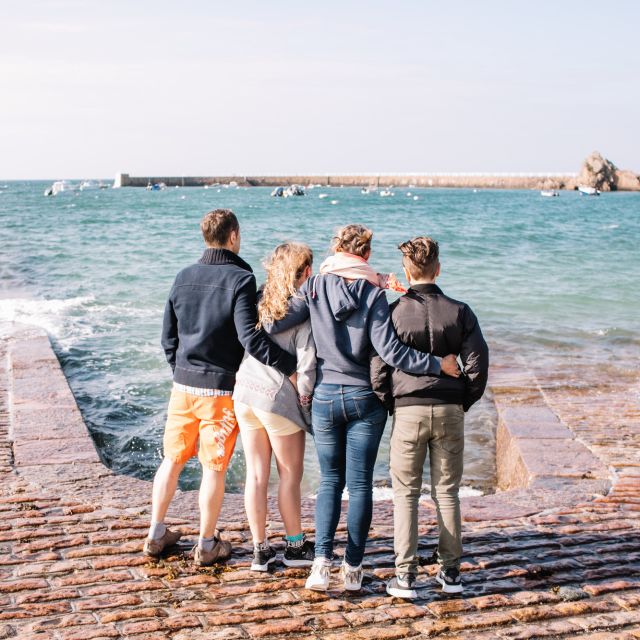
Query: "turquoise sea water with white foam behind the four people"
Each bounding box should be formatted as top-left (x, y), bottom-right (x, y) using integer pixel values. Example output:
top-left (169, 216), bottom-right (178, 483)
top-left (0, 182), bottom-right (640, 493)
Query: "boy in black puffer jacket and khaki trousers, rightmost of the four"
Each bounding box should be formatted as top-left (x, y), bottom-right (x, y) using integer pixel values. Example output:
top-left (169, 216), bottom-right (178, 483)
top-left (371, 237), bottom-right (489, 598)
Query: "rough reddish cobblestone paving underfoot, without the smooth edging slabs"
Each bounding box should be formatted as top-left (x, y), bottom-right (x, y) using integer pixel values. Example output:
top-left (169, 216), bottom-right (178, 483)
top-left (0, 338), bottom-right (640, 640)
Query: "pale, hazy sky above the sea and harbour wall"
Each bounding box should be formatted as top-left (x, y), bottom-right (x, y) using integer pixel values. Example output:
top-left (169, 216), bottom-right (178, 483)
top-left (0, 0), bottom-right (640, 179)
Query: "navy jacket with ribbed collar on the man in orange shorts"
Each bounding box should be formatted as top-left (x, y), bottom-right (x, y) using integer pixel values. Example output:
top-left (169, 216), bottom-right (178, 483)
top-left (161, 249), bottom-right (296, 391)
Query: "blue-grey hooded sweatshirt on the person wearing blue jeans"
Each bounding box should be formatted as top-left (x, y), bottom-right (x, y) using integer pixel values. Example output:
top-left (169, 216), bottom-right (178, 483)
top-left (265, 274), bottom-right (440, 386)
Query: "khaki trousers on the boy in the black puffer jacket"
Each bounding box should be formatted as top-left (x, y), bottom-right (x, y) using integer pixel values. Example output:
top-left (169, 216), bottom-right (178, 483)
top-left (390, 404), bottom-right (464, 575)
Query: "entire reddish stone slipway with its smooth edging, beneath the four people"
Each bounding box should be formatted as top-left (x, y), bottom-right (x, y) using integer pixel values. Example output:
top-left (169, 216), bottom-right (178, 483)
top-left (0, 327), bottom-right (640, 640)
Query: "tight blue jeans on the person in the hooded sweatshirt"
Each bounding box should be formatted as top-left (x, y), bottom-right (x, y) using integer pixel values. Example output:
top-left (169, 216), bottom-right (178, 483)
top-left (311, 383), bottom-right (387, 567)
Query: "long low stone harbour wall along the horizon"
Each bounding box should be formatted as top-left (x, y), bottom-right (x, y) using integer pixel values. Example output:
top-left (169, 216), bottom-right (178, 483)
top-left (113, 173), bottom-right (578, 190)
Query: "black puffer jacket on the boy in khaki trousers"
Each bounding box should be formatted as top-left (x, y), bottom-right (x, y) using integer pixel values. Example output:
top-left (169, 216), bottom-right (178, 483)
top-left (371, 284), bottom-right (489, 411)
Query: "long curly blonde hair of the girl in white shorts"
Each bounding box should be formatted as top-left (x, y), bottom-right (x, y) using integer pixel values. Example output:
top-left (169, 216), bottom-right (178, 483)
top-left (258, 242), bottom-right (313, 328)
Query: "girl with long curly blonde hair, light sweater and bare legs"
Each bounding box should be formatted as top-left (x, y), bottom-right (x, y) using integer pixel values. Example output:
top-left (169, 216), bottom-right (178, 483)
top-left (233, 242), bottom-right (316, 571)
